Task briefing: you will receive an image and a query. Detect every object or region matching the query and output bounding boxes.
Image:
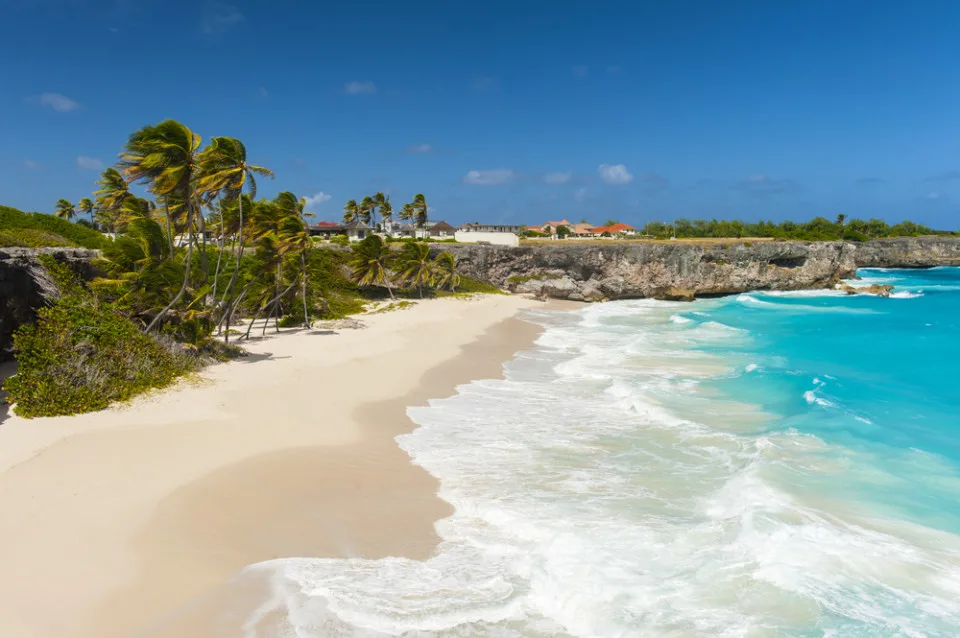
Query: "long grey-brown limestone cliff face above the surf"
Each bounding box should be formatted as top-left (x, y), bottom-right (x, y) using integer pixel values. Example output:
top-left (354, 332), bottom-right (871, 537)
top-left (444, 238), bottom-right (960, 301)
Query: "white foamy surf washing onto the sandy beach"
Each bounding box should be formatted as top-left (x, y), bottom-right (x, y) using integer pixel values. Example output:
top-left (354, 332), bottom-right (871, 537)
top-left (247, 302), bottom-right (960, 638)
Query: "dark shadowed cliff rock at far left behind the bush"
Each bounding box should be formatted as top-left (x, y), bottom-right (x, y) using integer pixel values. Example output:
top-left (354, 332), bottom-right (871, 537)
top-left (0, 248), bottom-right (96, 361)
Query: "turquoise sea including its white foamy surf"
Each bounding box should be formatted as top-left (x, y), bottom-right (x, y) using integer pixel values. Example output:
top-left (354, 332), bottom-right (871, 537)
top-left (252, 268), bottom-right (960, 638)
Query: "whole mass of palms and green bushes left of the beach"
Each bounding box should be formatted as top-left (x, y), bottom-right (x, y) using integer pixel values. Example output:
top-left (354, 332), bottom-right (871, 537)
top-left (0, 120), bottom-right (460, 416)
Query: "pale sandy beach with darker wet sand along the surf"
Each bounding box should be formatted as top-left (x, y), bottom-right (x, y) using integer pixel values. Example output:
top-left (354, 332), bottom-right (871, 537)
top-left (0, 296), bottom-right (538, 638)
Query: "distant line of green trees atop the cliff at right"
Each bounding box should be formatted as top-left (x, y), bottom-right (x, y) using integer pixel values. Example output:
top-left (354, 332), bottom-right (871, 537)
top-left (640, 215), bottom-right (952, 241)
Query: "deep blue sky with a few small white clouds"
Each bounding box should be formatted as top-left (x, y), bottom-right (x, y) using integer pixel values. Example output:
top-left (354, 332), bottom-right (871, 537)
top-left (0, 0), bottom-right (960, 229)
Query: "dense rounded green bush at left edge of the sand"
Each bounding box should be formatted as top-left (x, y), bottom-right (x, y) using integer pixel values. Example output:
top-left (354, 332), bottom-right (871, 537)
top-left (4, 259), bottom-right (203, 417)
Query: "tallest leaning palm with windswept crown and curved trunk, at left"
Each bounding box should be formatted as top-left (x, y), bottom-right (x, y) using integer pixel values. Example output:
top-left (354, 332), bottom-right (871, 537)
top-left (119, 120), bottom-right (203, 332)
